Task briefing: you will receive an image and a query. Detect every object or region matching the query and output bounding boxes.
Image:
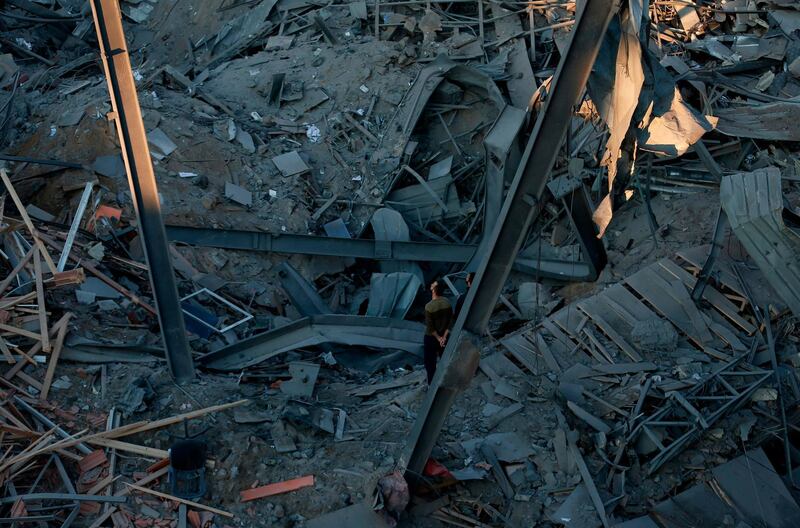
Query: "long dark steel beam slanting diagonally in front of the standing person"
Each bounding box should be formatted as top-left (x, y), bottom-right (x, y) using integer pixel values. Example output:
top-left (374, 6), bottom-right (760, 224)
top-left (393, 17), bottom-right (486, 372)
top-left (400, 0), bottom-right (619, 486)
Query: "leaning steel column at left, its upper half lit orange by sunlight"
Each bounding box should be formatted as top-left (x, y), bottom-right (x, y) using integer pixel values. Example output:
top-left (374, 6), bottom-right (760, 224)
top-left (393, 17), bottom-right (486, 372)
top-left (91, 0), bottom-right (194, 382)
